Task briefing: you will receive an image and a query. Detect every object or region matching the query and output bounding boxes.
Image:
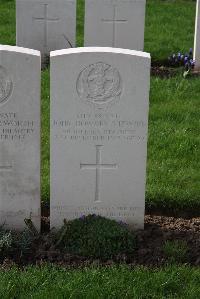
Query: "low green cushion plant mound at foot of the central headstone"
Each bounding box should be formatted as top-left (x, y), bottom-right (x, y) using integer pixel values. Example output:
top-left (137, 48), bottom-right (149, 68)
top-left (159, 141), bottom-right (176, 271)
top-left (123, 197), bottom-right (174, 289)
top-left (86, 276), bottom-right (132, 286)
top-left (59, 215), bottom-right (136, 259)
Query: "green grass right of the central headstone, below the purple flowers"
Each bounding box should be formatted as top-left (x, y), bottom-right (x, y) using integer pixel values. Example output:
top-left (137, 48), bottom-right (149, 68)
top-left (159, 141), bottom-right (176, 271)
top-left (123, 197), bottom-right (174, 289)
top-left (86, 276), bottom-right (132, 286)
top-left (146, 75), bottom-right (200, 210)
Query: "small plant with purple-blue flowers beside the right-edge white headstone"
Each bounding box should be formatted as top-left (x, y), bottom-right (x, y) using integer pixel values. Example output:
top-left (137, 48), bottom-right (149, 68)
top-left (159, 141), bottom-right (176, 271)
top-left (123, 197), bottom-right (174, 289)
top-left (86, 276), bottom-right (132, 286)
top-left (168, 48), bottom-right (195, 77)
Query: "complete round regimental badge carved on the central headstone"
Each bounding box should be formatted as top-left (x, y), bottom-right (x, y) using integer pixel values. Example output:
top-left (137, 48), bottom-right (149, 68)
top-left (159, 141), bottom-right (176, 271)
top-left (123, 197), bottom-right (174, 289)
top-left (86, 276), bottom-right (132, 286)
top-left (77, 62), bottom-right (122, 109)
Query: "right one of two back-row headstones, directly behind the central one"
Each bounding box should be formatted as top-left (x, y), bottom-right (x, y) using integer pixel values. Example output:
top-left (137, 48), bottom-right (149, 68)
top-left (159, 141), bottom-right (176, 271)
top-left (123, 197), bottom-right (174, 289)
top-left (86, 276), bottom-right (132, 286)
top-left (85, 0), bottom-right (146, 51)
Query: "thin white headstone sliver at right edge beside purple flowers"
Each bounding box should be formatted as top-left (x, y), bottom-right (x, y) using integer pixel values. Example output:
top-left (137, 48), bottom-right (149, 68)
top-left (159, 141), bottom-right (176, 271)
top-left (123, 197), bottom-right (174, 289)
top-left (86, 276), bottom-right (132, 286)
top-left (194, 0), bottom-right (200, 70)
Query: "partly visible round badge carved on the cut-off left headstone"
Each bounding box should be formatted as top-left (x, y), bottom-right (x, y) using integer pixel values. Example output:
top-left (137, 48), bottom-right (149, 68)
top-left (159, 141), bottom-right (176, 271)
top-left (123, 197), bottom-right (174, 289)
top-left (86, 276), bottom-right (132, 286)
top-left (0, 66), bottom-right (13, 104)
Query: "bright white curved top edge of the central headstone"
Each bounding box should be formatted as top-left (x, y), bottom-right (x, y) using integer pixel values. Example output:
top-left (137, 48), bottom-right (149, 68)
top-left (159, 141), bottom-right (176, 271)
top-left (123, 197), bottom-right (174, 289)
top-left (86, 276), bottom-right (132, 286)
top-left (50, 47), bottom-right (151, 59)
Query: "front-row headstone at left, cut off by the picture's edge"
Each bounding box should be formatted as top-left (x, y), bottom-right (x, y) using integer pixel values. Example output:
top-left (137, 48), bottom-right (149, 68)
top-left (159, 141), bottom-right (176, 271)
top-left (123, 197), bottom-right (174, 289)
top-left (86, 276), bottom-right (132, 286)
top-left (0, 46), bottom-right (41, 229)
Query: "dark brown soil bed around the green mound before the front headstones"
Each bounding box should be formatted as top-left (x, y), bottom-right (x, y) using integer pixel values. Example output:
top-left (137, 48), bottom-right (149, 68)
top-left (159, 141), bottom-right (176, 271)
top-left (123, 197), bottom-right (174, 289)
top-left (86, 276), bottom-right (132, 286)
top-left (1, 215), bottom-right (200, 268)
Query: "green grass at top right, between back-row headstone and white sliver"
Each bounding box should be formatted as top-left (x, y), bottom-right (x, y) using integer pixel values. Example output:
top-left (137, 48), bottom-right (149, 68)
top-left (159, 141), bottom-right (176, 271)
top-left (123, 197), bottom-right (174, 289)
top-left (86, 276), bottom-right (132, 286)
top-left (144, 0), bottom-right (196, 61)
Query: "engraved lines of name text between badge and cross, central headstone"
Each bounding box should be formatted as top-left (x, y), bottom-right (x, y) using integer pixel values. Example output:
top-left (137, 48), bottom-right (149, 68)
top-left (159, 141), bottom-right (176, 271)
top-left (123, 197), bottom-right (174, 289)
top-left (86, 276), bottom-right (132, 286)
top-left (53, 112), bottom-right (146, 142)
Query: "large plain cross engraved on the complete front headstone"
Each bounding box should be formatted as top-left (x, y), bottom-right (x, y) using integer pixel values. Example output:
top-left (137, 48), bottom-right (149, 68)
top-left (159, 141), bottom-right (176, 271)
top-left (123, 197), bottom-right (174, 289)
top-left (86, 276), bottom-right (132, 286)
top-left (80, 145), bottom-right (117, 202)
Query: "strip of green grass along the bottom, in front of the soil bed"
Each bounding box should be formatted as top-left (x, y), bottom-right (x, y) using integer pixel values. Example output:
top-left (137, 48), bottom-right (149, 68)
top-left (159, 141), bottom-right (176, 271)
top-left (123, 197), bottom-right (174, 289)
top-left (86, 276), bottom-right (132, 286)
top-left (0, 265), bottom-right (200, 299)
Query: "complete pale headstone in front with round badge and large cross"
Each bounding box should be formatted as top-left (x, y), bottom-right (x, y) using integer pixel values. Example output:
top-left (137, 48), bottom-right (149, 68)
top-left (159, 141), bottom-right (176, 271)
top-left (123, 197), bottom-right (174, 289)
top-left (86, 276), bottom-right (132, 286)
top-left (51, 47), bottom-right (150, 229)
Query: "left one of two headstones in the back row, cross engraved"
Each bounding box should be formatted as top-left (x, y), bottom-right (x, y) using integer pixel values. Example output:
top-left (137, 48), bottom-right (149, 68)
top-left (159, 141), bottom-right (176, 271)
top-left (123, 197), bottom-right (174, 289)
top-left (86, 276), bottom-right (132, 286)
top-left (16, 0), bottom-right (76, 63)
